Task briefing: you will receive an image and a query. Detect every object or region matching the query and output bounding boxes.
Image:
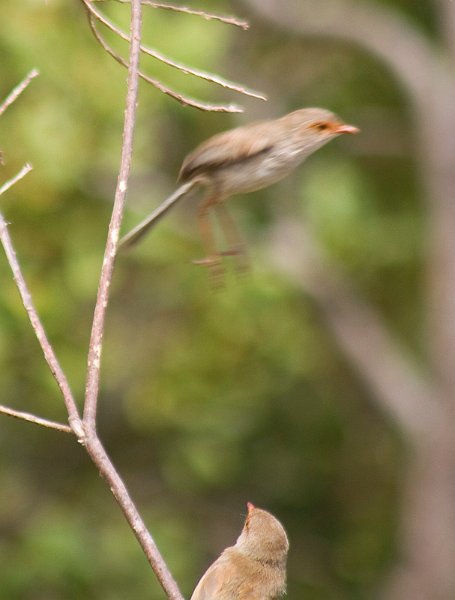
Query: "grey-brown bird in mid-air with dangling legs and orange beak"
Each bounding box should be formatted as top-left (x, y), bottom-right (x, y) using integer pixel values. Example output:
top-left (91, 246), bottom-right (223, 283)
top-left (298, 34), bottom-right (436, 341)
top-left (120, 108), bottom-right (359, 266)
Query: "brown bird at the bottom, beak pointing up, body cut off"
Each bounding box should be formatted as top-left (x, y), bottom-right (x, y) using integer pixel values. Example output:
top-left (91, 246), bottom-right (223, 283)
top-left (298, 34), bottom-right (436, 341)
top-left (191, 502), bottom-right (289, 600)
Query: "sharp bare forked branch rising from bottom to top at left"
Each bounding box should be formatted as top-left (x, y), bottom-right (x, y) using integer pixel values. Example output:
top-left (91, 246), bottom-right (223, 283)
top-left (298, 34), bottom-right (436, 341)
top-left (0, 5), bottom-right (183, 600)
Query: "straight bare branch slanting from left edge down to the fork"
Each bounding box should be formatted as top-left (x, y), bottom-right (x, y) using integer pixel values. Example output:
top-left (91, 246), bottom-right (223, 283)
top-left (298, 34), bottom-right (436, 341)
top-left (0, 213), bottom-right (83, 437)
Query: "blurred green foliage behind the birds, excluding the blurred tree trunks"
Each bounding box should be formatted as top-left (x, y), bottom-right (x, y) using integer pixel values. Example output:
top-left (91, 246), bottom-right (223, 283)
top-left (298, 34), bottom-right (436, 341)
top-left (0, 0), bottom-right (436, 600)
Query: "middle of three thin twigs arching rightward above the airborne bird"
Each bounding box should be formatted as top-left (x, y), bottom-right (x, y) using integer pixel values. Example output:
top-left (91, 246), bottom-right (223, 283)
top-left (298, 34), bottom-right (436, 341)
top-left (82, 0), bottom-right (267, 100)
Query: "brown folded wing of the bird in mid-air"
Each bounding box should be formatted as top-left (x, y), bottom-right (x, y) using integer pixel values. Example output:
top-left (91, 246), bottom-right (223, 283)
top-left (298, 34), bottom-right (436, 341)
top-left (178, 122), bottom-right (274, 182)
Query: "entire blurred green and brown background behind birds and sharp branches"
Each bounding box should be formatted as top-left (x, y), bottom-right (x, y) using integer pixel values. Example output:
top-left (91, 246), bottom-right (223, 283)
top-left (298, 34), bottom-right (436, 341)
top-left (0, 0), bottom-right (455, 600)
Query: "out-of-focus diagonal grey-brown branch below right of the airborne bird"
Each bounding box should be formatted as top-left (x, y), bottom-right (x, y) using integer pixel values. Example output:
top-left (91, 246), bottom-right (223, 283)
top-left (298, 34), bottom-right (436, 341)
top-left (271, 223), bottom-right (443, 436)
